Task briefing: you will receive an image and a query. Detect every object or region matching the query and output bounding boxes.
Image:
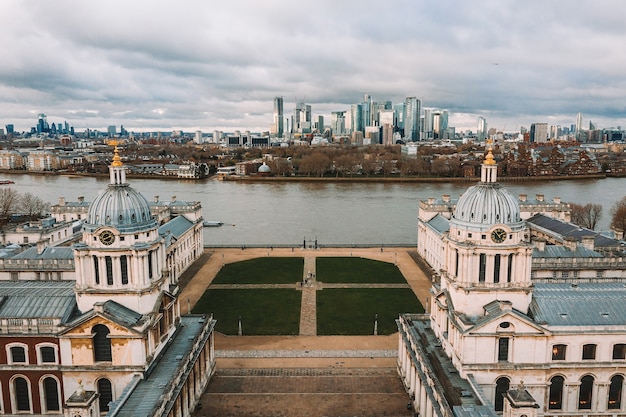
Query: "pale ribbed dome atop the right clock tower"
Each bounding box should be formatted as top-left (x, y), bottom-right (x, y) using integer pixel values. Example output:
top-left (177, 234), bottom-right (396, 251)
top-left (453, 182), bottom-right (521, 226)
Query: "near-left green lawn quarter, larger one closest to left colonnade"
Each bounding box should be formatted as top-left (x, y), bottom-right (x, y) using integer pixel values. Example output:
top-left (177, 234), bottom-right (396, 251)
top-left (192, 290), bottom-right (301, 336)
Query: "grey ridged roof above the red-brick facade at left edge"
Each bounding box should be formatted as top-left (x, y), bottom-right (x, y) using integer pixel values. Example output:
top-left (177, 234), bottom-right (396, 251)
top-left (0, 281), bottom-right (76, 322)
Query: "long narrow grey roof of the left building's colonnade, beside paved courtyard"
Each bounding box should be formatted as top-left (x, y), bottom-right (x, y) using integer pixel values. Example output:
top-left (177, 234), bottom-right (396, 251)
top-left (109, 316), bottom-right (209, 417)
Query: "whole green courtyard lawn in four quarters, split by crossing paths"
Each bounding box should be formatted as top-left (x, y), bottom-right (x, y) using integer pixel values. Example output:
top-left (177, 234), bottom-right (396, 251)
top-left (192, 257), bottom-right (424, 335)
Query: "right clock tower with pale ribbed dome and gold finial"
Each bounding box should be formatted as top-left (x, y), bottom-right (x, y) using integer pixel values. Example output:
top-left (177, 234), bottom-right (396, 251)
top-left (434, 147), bottom-right (532, 316)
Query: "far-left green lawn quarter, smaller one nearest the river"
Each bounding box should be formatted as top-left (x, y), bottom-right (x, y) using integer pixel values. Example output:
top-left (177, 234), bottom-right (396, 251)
top-left (213, 257), bottom-right (304, 284)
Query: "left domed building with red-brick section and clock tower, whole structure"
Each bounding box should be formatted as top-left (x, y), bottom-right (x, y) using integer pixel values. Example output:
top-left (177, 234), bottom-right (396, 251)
top-left (0, 147), bottom-right (215, 417)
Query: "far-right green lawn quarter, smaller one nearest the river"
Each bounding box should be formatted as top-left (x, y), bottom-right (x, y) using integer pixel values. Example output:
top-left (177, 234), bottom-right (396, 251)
top-left (315, 257), bottom-right (406, 284)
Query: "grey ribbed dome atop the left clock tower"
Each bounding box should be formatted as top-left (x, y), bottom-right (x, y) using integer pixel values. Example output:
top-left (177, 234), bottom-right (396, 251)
top-left (85, 184), bottom-right (157, 233)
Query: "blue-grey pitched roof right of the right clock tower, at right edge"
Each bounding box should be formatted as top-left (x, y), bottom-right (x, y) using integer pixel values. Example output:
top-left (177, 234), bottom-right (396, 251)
top-left (529, 283), bottom-right (626, 326)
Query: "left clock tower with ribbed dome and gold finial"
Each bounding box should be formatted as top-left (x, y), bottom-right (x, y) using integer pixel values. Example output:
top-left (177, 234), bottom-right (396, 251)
top-left (74, 144), bottom-right (170, 314)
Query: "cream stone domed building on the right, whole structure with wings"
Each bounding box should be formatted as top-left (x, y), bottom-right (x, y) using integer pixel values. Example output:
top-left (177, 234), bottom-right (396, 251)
top-left (398, 149), bottom-right (626, 417)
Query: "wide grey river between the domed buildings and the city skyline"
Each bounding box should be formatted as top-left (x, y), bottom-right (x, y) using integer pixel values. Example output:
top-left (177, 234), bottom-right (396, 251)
top-left (3, 174), bottom-right (626, 246)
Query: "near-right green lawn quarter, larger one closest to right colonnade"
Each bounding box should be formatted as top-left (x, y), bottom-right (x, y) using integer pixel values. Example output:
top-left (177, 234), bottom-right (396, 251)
top-left (317, 286), bottom-right (424, 336)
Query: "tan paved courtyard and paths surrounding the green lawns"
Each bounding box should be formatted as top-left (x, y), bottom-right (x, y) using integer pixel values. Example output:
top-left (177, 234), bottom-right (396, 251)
top-left (179, 247), bottom-right (431, 417)
